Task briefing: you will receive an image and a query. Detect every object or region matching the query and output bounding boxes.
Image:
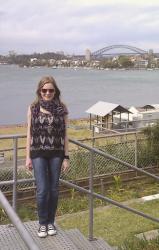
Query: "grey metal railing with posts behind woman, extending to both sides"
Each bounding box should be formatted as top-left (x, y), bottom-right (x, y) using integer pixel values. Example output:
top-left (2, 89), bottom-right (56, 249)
top-left (0, 135), bottom-right (159, 240)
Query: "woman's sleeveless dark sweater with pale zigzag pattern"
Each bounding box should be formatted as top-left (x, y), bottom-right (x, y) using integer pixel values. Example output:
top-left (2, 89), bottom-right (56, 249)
top-left (30, 106), bottom-right (65, 158)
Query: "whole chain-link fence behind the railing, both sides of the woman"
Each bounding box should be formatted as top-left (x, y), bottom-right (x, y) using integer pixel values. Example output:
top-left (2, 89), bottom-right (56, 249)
top-left (0, 132), bottom-right (157, 191)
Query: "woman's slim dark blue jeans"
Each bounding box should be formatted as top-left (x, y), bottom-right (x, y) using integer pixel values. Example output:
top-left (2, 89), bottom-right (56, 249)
top-left (32, 157), bottom-right (62, 225)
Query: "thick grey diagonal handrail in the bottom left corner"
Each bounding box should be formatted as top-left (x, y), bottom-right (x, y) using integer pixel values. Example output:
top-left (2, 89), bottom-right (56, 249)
top-left (0, 190), bottom-right (40, 250)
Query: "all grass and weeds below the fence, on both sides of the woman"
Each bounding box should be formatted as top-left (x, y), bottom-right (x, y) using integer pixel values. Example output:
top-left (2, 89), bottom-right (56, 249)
top-left (0, 181), bottom-right (159, 250)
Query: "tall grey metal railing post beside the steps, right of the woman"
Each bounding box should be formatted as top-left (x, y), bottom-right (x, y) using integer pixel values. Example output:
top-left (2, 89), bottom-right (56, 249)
top-left (88, 148), bottom-right (94, 241)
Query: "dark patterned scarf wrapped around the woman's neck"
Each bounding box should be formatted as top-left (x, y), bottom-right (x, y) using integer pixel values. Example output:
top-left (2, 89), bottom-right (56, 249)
top-left (32, 99), bottom-right (68, 116)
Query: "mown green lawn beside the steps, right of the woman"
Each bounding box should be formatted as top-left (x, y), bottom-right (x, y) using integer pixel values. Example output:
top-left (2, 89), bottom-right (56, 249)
top-left (57, 200), bottom-right (159, 246)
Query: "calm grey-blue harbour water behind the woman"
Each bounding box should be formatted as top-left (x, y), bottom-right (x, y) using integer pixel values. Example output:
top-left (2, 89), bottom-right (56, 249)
top-left (0, 65), bottom-right (159, 125)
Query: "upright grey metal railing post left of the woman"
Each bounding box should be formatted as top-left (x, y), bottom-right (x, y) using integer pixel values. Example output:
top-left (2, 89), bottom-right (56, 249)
top-left (12, 137), bottom-right (18, 211)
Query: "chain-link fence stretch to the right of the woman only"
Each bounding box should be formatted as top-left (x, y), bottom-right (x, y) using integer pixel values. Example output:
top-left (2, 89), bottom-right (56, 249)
top-left (63, 132), bottom-right (157, 181)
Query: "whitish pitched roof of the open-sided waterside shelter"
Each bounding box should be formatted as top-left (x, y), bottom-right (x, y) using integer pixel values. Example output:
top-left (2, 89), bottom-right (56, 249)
top-left (86, 101), bottom-right (131, 116)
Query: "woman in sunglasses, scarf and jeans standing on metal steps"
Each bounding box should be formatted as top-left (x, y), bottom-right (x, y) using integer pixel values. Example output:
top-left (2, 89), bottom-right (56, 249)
top-left (26, 76), bottom-right (69, 237)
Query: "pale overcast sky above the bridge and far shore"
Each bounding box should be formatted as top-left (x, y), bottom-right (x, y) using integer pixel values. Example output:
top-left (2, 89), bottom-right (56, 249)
top-left (0, 0), bottom-right (159, 55)
